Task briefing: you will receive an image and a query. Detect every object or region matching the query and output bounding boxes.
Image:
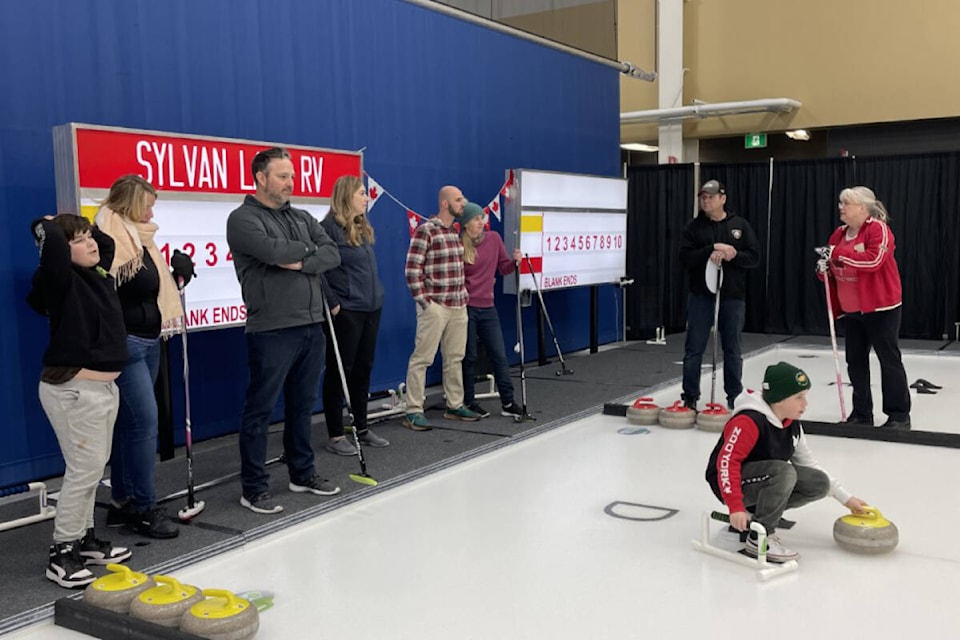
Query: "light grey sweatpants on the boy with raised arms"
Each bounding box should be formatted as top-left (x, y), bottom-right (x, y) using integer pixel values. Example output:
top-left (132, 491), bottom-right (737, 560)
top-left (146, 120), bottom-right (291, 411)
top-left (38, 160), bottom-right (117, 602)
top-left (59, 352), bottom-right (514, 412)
top-left (39, 378), bottom-right (120, 542)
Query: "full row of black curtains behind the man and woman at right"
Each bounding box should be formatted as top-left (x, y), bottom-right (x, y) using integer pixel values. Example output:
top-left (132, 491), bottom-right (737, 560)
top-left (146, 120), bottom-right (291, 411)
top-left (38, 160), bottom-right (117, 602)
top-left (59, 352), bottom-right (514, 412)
top-left (627, 152), bottom-right (960, 340)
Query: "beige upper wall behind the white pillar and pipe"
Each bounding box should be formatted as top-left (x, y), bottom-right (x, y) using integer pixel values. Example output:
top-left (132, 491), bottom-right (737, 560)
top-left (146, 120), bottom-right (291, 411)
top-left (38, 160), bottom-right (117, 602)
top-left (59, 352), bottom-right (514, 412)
top-left (618, 0), bottom-right (960, 141)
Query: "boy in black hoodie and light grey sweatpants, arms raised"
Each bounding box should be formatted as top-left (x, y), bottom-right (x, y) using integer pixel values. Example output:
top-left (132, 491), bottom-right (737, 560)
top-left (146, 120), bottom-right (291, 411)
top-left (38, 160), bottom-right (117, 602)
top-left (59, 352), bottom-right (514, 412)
top-left (27, 214), bottom-right (132, 587)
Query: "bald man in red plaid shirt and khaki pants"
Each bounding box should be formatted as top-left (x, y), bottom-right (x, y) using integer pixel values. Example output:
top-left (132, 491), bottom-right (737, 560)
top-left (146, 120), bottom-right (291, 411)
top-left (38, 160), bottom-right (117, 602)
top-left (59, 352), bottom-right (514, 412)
top-left (403, 186), bottom-right (480, 431)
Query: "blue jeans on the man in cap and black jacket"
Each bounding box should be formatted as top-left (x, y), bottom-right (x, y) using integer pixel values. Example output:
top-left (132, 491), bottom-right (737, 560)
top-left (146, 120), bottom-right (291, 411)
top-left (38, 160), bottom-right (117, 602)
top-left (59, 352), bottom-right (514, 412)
top-left (683, 293), bottom-right (746, 404)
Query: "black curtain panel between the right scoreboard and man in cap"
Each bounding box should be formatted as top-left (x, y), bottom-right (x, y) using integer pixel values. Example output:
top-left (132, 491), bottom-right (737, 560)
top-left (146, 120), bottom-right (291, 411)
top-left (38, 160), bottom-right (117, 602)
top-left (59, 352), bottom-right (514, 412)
top-left (626, 164), bottom-right (696, 340)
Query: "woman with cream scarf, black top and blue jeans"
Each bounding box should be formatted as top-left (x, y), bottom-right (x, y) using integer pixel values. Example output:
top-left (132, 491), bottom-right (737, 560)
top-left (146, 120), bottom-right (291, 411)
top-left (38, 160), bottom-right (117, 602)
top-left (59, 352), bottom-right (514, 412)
top-left (95, 175), bottom-right (183, 538)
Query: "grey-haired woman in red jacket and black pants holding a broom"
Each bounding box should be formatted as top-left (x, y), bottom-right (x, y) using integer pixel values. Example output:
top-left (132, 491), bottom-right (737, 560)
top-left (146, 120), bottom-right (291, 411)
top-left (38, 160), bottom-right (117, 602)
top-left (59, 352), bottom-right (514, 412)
top-left (818, 187), bottom-right (910, 429)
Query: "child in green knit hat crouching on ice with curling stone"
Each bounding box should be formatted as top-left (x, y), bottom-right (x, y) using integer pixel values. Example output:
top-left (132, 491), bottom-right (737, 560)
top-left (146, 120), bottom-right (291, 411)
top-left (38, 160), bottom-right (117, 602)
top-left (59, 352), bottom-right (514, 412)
top-left (706, 362), bottom-right (867, 562)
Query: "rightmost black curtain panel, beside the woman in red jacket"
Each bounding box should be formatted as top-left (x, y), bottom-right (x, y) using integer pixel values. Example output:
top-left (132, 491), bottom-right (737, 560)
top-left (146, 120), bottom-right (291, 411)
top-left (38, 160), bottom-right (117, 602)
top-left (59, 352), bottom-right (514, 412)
top-left (853, 153), bottom-right (960, 340)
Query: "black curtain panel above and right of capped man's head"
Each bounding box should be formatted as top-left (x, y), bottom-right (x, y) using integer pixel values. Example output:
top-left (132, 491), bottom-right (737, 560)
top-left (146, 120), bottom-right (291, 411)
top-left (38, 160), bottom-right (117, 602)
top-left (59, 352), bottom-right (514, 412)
top-left (700, 160), bottom-right (776, 333)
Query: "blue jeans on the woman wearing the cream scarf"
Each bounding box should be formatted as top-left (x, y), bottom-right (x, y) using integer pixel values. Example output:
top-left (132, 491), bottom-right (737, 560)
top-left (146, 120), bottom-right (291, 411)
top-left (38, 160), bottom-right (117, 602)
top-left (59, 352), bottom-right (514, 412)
top-left (110, 336), bottom-right (160, 511)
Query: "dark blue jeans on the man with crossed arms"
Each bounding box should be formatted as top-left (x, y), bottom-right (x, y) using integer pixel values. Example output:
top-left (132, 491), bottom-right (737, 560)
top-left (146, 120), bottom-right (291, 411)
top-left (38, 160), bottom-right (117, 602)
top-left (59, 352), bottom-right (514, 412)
top-left (240, 322), bottom-right (326, 498)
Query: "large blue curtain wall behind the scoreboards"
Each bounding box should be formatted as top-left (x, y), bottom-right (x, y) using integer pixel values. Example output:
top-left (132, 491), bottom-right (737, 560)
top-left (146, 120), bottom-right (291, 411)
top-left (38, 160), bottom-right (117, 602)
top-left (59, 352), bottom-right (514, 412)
top-left (0, 0), bottom-right (621, 486)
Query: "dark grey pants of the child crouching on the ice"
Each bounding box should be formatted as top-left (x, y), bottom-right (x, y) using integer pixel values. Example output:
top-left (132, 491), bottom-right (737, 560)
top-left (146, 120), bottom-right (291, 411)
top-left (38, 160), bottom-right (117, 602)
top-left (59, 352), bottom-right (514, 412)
top-left (740, 460), bottom-right (830, 535)
